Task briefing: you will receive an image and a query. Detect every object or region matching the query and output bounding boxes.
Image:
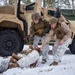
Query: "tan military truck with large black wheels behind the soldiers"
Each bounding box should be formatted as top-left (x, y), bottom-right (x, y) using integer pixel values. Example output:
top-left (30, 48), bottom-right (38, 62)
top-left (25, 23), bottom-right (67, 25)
top-left (0, 0), bottom-right (75, 56)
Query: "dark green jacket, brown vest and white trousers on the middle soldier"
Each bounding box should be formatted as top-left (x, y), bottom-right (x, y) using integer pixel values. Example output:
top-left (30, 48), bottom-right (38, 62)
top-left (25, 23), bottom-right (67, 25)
top-left (29, 19), bottom-right (50, 63)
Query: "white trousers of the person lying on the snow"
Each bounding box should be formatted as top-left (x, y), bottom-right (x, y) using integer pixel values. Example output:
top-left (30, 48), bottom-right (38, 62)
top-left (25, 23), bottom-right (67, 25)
top-left (17, 50), bottom-right (39, 68)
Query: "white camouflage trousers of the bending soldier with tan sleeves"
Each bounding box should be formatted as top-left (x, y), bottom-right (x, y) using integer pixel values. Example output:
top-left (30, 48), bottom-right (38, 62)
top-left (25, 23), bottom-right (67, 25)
top-left (53, 38), bottom-right (71, 62)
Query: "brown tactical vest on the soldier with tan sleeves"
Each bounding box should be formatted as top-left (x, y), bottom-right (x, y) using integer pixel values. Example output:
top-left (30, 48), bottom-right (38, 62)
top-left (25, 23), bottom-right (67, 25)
top-left (54, 25), bottom-right (66, 39)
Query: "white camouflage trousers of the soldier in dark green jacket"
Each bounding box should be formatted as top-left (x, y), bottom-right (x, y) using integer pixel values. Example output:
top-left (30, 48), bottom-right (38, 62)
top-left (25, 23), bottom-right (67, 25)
top-left (33, 35), bottom-right (49, 59)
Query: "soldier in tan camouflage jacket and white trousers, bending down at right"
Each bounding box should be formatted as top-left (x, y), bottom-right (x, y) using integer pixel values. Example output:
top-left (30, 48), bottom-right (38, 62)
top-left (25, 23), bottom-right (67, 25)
top-left (40, 17), bottom-right (71, 65)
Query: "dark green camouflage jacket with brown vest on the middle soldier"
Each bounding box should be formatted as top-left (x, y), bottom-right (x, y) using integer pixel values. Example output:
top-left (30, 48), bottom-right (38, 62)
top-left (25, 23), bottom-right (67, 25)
top-left (29, 19), bottom-right (50, 44)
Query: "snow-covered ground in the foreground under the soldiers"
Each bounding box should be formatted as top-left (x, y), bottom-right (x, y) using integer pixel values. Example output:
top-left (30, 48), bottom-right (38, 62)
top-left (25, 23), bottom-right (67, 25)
top-left (0, 46), bottom-right (75, 75)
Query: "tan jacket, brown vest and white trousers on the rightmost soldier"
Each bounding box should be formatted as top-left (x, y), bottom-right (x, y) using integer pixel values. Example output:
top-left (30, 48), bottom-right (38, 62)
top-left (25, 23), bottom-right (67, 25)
top-left (42, 22), bottom-right (71, 62)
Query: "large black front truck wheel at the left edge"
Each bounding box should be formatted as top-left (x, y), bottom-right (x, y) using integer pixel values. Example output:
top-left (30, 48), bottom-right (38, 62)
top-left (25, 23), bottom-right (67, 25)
top-left (0, 29), bottom-right (24, 56)
